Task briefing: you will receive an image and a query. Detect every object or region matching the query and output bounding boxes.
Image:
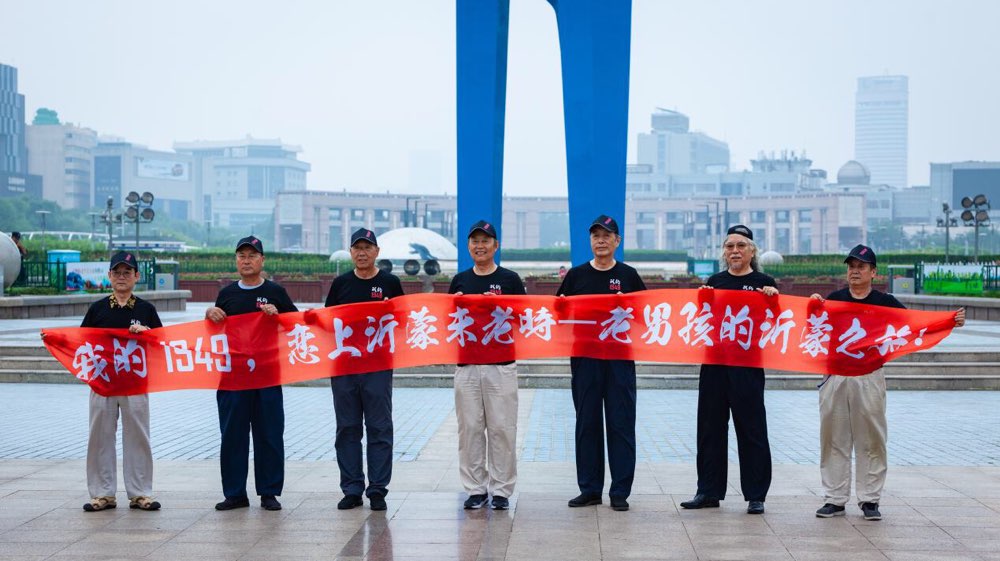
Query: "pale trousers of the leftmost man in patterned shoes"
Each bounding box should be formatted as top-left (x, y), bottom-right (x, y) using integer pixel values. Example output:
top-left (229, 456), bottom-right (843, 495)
top-left (87, 391), bottom-right (153, 499)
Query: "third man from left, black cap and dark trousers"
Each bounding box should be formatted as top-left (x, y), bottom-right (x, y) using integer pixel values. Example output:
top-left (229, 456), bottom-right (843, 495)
top-left (326, 228), bottom-right (403, 510)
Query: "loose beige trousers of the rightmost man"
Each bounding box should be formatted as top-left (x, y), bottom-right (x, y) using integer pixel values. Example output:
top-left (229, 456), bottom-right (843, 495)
top-left (819, 370), bottom-right (887, 506)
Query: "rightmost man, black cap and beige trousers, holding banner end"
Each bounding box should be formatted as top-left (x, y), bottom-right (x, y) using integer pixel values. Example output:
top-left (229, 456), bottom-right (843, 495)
top-left (812, 245), bottom-right (965, 520)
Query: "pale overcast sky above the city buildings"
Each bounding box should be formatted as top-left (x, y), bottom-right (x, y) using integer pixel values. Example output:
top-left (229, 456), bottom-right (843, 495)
top-left (0, 0), bottom-right (1000, 195)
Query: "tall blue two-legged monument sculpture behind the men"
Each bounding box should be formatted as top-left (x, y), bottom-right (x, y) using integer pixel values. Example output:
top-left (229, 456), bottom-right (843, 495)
top-left (456, 0), bottom-right (632, 270)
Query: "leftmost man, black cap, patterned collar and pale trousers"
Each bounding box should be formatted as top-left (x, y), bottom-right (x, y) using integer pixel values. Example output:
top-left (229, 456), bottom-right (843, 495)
top-left (80, 251), bottom-right (163, 512)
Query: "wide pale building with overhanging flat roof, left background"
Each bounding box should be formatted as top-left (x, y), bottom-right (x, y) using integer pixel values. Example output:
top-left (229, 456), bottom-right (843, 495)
top-left (174, 137), bottom-right (311, 229)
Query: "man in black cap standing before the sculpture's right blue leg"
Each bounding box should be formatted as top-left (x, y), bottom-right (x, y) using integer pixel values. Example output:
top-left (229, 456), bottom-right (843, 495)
top-left (557, 215), bottom-right (646, 511)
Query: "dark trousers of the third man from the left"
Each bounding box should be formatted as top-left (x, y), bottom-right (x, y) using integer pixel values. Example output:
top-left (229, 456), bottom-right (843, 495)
top-left (330, 370), bottom-right (392, 497)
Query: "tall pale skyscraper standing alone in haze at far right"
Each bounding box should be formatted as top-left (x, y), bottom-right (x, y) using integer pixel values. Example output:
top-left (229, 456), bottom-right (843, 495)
top-left (854, 76), bottom-right (910, 189)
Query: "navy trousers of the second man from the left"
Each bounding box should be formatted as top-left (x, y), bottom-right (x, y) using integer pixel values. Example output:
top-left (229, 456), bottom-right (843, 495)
top-left (215, 386), bottom-right (285, 498)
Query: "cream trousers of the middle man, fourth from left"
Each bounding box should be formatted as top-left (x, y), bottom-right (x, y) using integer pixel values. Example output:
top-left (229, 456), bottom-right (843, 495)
top-left (455, 363), bottom-right (517, 498)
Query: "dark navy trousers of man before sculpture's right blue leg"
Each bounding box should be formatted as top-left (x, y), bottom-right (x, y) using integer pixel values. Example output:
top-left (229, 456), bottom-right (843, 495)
top-left (569, 357), bottom-right (636, 498)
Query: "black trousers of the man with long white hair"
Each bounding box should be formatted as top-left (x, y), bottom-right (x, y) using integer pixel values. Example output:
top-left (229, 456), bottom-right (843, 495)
top-left (698, 364), bottom-right (771, 501)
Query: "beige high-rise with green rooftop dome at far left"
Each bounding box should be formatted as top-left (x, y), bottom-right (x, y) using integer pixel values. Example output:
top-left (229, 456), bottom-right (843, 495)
top-left (25, 109), bottom-right (97, 209)
